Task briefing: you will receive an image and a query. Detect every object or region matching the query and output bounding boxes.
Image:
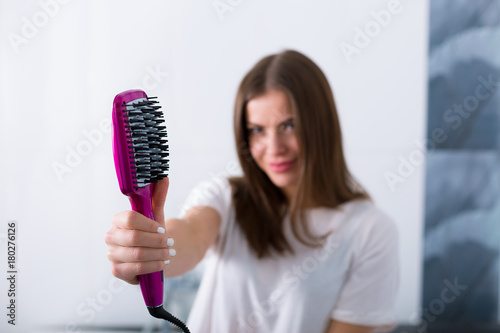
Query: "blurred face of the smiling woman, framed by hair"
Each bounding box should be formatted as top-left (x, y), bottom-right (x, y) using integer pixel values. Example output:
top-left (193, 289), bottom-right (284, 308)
top-left (246, 90), bottom-right (299, 199)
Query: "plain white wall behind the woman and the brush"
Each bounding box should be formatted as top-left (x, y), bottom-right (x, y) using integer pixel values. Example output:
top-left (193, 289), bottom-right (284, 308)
top-left (0, 0), bottom-right (428, 332)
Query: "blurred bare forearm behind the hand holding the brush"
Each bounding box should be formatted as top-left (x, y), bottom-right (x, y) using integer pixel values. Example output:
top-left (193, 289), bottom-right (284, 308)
top-left (163, 219), bottom-right (205, 277)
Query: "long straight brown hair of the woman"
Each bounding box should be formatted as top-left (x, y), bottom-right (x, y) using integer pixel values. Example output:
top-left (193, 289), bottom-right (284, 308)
top-left (229, 50), bottom-right (368, 258)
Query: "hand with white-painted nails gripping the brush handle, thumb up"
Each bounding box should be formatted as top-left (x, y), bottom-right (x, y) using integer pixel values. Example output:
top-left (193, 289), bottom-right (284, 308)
top-left (104, 178), bottom-right (175, 284)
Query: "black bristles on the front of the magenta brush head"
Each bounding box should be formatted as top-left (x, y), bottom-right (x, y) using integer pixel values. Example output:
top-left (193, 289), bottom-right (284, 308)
top-left (124, 97), bottom-right (169, 189)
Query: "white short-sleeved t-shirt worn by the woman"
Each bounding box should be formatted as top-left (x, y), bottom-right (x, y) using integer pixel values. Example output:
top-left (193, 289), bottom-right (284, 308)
top-left (181, 178), bottom-right (399, 333)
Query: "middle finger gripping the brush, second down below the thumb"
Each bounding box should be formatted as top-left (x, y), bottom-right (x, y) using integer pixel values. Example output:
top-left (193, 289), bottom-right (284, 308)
top-left (108, 229), bottom-right (171, 248)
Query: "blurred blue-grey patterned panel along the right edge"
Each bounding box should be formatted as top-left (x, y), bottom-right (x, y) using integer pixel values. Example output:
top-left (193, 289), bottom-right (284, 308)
top-left (421, 0), bottom-right (500, 325)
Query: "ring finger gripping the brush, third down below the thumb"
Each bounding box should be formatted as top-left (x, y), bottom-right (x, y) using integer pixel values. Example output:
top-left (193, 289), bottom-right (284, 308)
top-left (108, 246), bottom-right (175, 263)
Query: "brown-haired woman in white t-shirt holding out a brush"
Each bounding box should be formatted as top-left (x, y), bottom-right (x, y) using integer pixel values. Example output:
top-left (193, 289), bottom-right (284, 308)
top-left (106, 51), bottom-right (398, 333)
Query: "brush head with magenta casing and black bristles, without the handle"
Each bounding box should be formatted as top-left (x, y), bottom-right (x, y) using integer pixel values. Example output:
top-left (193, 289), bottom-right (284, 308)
top-left (113, 90), bottom-right (169, 196)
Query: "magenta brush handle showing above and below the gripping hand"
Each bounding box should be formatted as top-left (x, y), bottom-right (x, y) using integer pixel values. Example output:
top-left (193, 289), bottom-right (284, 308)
top-left (129, 191), bottom-right (163, 307)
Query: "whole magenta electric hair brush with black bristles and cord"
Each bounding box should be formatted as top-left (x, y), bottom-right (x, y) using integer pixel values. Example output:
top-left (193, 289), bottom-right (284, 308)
top-left (113, 90), bottom-right (189, 332)
